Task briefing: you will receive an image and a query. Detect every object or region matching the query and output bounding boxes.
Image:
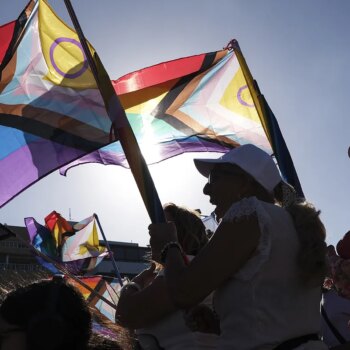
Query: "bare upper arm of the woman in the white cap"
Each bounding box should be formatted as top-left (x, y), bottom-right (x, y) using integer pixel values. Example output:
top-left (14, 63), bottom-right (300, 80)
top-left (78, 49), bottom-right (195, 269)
top-left (168, 216), bottom-right (260, 308)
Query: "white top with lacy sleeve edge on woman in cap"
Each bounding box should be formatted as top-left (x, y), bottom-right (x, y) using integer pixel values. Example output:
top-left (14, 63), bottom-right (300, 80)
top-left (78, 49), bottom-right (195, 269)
top-left (214, 197), bottom-right (327, 350)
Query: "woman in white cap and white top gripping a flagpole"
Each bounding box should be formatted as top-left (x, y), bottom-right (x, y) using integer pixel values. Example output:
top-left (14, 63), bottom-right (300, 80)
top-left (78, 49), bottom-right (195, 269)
top-left (149, 145), bottom-right (326, 350)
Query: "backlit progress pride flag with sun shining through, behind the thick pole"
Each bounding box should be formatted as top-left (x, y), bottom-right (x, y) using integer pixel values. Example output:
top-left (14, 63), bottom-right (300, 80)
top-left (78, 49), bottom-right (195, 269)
top-left (60, 49), bottom-right (272, 174)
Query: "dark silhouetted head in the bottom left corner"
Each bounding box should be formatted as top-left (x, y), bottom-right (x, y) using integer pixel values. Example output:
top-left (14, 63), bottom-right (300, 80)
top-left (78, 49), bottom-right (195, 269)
top-left (0, 279), bottom-right (91, 350)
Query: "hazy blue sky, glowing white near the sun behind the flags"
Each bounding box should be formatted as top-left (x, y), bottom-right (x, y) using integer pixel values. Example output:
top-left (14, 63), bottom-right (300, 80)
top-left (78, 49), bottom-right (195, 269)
top-left (0, 0), bottom-right (350, 245)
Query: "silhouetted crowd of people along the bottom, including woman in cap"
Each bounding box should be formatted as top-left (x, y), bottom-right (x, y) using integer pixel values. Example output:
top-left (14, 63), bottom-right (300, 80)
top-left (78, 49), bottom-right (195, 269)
top-left (0, 145), bottom-right (350, 350)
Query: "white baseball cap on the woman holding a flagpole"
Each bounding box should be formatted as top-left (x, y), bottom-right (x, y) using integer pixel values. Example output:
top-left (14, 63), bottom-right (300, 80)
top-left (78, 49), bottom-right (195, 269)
top-left (194, 144), bottom-right (282, 193)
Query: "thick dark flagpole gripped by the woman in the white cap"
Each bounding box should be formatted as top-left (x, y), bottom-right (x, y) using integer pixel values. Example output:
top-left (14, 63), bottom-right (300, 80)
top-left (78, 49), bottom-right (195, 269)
top-left (64, 0), bottom-right (165, 223)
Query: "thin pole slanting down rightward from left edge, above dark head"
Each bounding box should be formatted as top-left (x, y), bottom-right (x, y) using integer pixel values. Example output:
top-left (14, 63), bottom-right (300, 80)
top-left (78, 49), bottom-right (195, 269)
top-left (0, 223), bottom-right (117, 310)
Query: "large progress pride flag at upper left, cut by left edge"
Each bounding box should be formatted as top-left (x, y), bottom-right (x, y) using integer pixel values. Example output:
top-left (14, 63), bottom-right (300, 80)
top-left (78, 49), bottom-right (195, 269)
top-left (0, 0), bottom-right (124, 207)
